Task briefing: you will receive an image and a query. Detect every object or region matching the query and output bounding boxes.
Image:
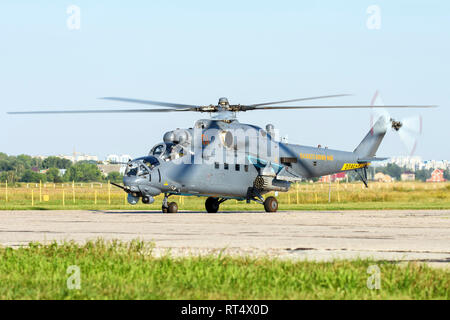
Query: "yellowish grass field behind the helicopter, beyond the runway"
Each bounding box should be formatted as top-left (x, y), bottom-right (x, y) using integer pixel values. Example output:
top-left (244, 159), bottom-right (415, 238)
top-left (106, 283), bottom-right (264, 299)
top-left (0, 182), bottom-right (450, 211)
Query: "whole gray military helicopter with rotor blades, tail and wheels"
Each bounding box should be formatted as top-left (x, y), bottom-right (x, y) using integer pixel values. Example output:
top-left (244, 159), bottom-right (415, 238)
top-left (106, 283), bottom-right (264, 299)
top-left (9, 94), bottom-right (433, 213)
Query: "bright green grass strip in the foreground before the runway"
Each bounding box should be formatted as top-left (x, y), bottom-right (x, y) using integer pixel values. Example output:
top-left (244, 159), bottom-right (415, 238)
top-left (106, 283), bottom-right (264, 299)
top-left (0, 240), bottom-right (450, 299)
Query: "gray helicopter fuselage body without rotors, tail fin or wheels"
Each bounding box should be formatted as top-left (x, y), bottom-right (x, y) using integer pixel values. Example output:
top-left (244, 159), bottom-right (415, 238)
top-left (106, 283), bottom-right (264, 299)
top-left (124, 120), bottom-right (369, 203)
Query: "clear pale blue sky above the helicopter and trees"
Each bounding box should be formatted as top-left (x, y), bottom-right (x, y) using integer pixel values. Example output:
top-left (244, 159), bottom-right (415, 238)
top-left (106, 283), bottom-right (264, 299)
top-left (0, 0), bottom-right (450, 159)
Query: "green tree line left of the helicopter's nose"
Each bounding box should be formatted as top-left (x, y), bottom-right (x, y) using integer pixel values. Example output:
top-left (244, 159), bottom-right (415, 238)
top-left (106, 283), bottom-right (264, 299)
top-left (0, 152), bottom-right (122, 184)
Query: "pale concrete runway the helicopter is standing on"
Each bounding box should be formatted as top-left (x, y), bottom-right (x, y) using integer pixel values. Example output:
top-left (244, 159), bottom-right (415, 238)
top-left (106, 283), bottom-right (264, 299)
top-left (0, 210), bottom-right (450, 268)
